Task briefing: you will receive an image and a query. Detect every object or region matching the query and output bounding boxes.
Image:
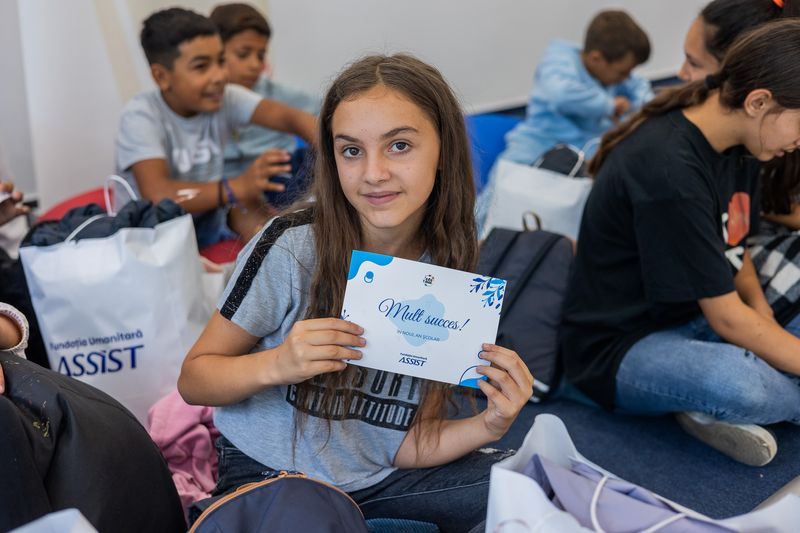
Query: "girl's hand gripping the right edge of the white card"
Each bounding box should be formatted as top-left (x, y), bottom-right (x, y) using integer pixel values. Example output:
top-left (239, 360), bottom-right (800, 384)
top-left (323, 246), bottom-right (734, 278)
top-left (477, 344), bottom-right (533, 439)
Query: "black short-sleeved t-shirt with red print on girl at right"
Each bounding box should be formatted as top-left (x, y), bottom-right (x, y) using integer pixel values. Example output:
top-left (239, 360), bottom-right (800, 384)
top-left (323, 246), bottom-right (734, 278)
top-left (562, 110), bottom-right (759, 409)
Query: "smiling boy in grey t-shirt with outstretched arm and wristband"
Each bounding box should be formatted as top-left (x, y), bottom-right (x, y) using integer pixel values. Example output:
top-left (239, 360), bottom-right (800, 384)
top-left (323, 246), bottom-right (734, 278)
top-left (116, 8), bottom-right (316, 247)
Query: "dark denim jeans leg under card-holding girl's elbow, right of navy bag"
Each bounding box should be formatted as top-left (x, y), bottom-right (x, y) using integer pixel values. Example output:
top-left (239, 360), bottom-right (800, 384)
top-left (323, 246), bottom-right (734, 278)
top-left (350, 448), bottom-right (513, 532)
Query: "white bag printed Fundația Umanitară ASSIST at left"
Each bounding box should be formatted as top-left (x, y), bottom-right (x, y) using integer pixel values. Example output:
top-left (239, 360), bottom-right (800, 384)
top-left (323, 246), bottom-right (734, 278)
top-left (21, 177), bottom-right (213, 423)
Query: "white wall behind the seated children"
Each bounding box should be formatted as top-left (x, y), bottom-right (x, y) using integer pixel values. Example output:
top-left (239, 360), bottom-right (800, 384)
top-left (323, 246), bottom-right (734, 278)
top-left (0, 0), bottom-right (705, 209)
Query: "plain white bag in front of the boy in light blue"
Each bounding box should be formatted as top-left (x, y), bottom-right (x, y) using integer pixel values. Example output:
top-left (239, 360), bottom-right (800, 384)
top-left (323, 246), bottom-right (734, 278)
top-left (483, 159), bottom-right (593, 240)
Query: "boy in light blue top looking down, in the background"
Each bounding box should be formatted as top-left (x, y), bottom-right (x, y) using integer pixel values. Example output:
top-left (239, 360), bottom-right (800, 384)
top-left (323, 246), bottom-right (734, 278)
top-left (500, 10), bottom-right (653, 165)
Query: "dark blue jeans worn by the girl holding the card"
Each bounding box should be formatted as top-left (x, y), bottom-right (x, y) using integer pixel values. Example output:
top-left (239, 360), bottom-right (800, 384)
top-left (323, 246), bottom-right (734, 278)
top-left (208, 437), bottom-right (514, 532)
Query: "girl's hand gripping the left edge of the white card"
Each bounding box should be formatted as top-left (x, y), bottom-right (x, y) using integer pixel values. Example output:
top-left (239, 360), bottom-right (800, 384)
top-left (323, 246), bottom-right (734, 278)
top-left (274, 318), bottom-right (367, 385)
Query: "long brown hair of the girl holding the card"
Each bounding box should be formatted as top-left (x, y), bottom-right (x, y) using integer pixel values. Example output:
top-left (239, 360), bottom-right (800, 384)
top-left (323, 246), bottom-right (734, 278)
top-left (295, 54), bottom-right (478, 442)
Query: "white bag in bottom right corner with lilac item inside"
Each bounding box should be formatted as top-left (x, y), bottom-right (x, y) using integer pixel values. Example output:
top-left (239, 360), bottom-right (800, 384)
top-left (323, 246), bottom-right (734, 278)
top-left (486, 414), bottom-right (800, 533)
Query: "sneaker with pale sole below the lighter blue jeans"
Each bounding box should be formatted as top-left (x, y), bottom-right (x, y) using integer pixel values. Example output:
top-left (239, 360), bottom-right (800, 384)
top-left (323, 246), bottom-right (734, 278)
top-left (675, 412), bottom-right (778, 466)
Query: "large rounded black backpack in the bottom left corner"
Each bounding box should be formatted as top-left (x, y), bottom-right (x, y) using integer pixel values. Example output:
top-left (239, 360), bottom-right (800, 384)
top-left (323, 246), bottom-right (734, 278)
top-left (0, 350), bottom-right (186, 533)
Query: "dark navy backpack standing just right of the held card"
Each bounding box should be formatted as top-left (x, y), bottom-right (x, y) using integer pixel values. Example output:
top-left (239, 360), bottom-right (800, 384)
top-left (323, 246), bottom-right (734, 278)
top-left (478, 222), bottom-right (574, 402)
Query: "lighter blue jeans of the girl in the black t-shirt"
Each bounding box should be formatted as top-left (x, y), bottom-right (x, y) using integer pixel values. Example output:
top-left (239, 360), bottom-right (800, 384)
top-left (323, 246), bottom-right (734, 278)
top-left (615, 316), bottom-right (800, 424)
